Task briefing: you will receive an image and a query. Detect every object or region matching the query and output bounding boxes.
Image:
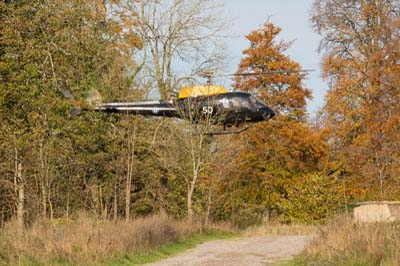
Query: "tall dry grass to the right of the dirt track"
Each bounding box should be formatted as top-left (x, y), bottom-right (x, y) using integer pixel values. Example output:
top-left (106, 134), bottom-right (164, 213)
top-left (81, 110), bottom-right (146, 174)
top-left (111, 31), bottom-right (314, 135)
top-left (292, 217), bottom-right (400, 266)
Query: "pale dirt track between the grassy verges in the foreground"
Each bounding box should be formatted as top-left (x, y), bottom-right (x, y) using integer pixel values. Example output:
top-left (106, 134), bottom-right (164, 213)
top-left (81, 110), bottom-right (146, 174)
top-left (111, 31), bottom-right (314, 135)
top-left (146, 236), bottom-right (310, 266)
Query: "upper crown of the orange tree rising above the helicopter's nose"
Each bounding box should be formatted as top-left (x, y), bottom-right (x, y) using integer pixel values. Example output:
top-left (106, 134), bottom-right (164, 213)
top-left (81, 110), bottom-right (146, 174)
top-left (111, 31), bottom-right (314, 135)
top-left (234, 23), bottom-right (311, 121)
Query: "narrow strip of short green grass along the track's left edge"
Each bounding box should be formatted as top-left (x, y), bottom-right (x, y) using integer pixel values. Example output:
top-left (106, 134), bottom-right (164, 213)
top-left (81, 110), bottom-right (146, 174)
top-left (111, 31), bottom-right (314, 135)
top-left (105, 231), bottom-right (238, 266)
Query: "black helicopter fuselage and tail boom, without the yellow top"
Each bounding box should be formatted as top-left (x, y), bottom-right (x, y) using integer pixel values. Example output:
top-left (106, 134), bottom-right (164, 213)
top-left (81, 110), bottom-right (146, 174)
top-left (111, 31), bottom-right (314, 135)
top-left (95, 92), bottom-right (275, 126)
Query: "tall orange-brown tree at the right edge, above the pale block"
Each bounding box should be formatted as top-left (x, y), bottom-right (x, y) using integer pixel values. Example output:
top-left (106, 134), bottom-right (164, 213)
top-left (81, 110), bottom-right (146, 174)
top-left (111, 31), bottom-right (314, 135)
top-left (311, 0), bottom-right (400, 199)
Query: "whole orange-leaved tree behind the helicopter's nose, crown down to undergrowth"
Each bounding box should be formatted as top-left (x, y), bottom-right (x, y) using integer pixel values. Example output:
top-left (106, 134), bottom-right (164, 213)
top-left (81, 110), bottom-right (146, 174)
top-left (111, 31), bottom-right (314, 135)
top-left (211, 23), bottom-right (327, 225)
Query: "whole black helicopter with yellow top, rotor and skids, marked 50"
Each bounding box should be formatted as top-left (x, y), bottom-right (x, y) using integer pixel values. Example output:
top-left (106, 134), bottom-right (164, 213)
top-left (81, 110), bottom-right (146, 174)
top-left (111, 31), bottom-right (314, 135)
top-left (94, 70), bottom-right (310, 135)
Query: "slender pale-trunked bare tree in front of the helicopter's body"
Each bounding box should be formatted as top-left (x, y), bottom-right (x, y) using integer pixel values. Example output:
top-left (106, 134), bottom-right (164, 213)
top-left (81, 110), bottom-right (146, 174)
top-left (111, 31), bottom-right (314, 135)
top-left (154, 98), bottom-right (228, 221)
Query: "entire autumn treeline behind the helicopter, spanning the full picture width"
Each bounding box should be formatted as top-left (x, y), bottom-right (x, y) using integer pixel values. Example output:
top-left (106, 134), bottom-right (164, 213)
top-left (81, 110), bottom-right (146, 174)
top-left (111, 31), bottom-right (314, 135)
top-left (0, 0), bottom-right (400, 231)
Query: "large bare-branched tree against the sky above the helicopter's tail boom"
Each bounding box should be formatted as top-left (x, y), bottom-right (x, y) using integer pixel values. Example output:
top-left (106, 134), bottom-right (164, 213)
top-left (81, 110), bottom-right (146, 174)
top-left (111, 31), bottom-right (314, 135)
top-left (125, 0), bottom-right (226, 99)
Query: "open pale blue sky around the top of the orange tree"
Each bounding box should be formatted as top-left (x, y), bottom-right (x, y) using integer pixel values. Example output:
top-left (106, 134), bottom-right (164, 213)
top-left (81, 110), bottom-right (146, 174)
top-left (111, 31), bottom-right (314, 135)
top-left (220, 0), bottom-right (328, 116)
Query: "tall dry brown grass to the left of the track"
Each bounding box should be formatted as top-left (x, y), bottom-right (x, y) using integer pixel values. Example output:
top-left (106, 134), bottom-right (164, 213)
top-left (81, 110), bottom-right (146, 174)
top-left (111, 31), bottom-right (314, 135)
top-left (0, 215), bottom-right (228, 265)
